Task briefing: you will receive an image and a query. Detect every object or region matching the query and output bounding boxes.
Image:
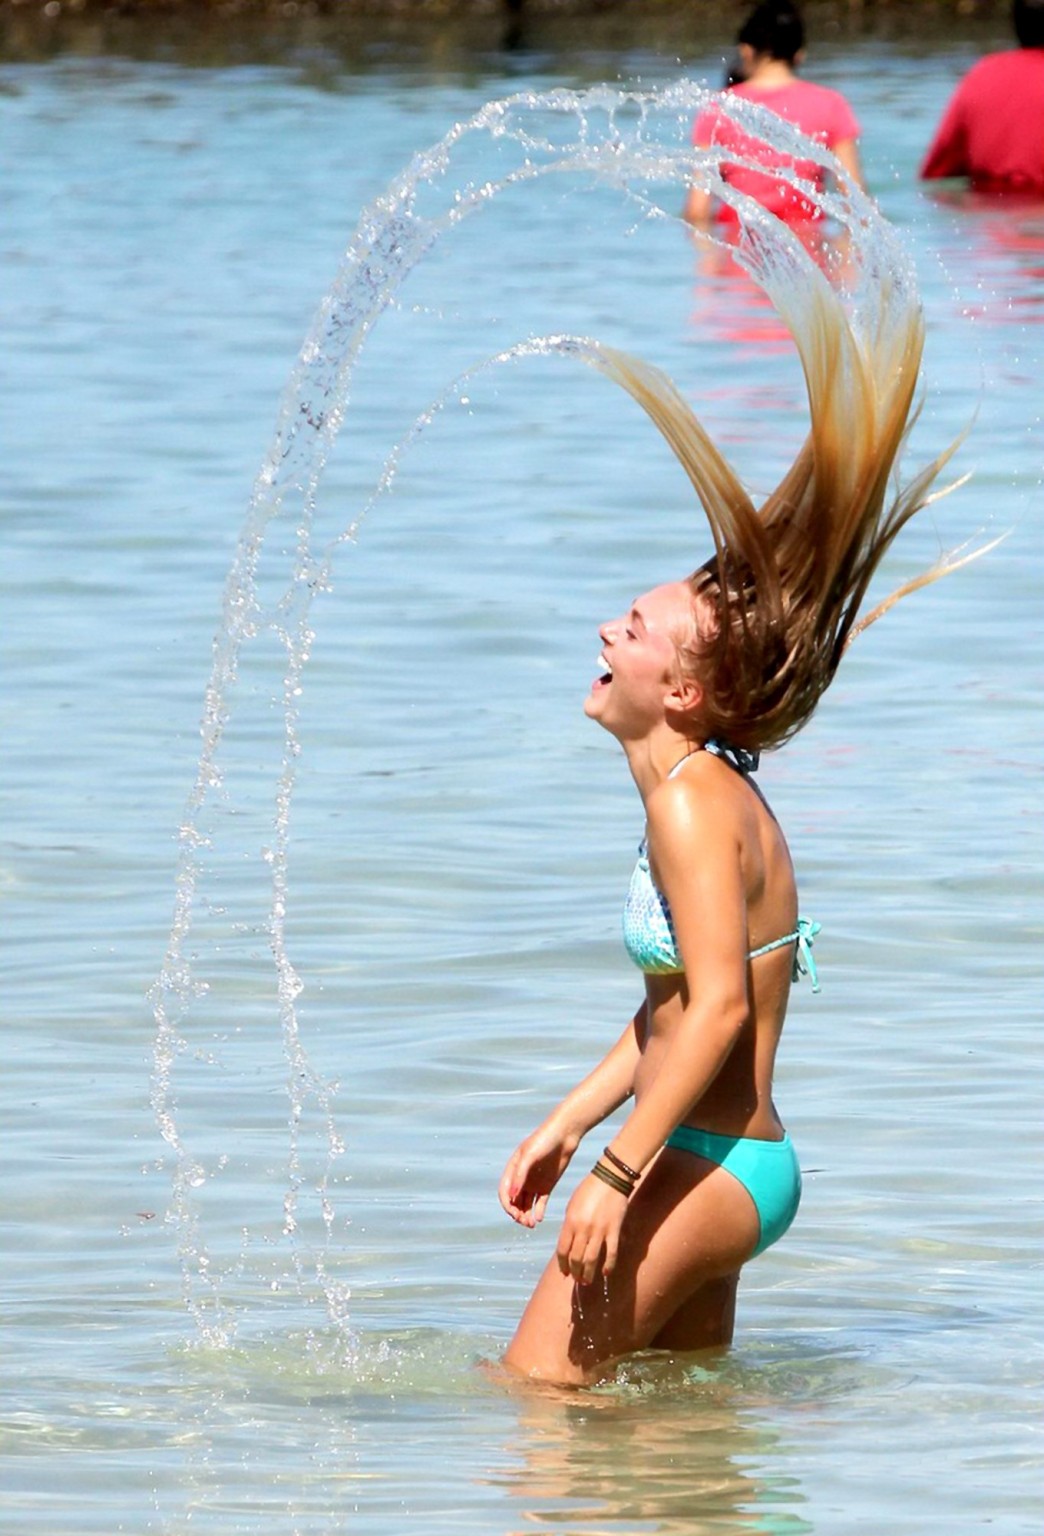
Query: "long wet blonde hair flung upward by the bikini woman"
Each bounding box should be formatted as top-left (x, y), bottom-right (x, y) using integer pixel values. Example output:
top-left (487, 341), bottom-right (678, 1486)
top-left (574, 267), bottom-right (964, 750)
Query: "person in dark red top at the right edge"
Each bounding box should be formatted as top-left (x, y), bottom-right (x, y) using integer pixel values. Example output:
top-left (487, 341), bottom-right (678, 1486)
top-left (921, 0), bottom-right (1044, 192)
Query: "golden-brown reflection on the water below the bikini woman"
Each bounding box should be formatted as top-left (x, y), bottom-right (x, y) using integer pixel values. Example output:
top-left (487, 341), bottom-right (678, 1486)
top-left (491, 1362), bottom-right (812, 1536)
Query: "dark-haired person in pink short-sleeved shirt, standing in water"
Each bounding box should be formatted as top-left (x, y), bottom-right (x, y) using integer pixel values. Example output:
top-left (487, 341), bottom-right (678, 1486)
top-left (683, 0), bottom-right (863, 224)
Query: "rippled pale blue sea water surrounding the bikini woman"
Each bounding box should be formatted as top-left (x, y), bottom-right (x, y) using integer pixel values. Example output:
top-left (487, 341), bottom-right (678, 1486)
top-left (0, 36), bottom-right (1044, 1536)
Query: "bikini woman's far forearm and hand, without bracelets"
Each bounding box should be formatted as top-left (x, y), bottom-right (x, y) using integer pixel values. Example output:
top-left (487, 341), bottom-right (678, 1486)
top-left (499, 1003), bottom-right (645, 1227)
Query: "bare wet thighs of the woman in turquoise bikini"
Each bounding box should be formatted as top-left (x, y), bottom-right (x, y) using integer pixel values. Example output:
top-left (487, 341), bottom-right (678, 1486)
top-left (504, 1147), bottom-right (760, 1385)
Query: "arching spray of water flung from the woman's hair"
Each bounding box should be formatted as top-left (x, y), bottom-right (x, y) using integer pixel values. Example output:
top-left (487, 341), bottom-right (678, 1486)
top-left (150, 83), bottom-right (917, 1347)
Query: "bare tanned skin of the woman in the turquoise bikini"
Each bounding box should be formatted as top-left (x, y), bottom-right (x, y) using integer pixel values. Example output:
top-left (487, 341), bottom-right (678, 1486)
top-left (499, 582), bottom-right (797, 1385)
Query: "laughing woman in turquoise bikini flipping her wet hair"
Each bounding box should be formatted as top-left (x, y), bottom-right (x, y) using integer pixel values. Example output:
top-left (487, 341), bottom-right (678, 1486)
top-left (501, 227), bottom-right (970, 1385)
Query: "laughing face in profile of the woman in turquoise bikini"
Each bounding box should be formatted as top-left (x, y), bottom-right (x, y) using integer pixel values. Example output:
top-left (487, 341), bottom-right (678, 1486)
top-left (583, 581), bottom-right (694, 737)
